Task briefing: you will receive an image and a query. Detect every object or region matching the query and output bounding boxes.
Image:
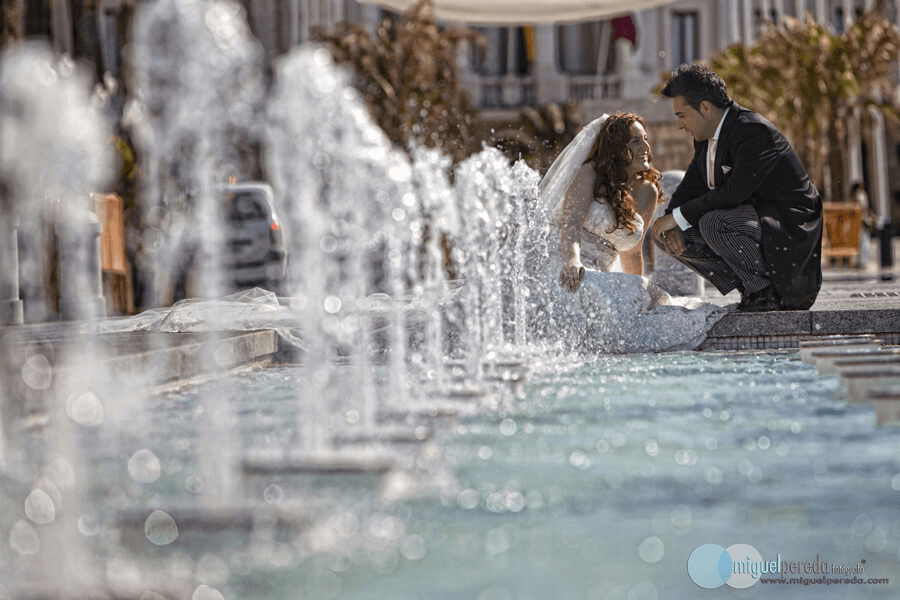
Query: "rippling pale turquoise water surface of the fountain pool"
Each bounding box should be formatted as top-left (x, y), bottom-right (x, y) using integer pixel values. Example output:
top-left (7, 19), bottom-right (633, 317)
top-left (3, 352), bottom-right (900, 599)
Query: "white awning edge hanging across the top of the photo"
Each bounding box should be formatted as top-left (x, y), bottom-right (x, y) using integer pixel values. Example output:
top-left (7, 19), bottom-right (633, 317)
top-left (361, 0), bottom-right (673, 25)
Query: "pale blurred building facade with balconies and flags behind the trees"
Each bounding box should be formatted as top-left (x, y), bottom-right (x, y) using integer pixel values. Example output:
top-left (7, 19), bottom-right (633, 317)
top-left (0, 0), bottom-right (900, 202)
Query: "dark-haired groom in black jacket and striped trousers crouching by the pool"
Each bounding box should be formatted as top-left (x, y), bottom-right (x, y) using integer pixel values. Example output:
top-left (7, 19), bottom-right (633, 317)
top-left (650, 64), bottom-right (822, 312)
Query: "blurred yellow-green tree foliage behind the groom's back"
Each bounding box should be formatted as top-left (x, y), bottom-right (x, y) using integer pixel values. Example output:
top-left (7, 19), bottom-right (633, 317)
top-left (710, 0), bottom-right (900, 200)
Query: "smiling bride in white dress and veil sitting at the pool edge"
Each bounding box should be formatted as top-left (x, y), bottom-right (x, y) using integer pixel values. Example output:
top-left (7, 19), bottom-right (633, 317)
top-left (536, 113), bottom-right (727, 353)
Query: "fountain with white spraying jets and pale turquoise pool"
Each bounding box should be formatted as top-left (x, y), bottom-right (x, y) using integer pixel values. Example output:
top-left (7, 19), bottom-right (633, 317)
top-left (0, 0), bottom-right (900, 600)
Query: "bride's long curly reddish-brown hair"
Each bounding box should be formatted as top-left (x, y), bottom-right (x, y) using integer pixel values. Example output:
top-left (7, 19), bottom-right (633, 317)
top-left (585, 112), bottom-right (663, 233)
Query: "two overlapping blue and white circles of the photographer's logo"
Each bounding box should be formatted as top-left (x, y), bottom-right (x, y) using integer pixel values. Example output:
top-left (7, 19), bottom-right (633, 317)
top-left (688, 544), bottom-right (762, 590)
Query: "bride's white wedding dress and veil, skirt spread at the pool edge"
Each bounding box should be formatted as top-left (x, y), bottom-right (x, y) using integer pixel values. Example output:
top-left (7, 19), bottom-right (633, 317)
top-left (532, 115), bottom-right (728, 353)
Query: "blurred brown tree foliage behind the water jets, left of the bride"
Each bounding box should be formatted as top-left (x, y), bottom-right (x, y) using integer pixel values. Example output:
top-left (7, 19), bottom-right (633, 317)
top-left (313, 0), bottom-right (483, 162)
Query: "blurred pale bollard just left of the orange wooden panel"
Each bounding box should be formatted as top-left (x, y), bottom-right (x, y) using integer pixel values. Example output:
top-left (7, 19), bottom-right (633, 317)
top-left (55, 196), bottom-right (105, 320)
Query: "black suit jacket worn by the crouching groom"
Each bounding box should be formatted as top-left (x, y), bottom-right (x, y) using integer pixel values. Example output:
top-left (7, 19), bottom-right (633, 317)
top-left (667, 102), bottom-right (822, 309)
